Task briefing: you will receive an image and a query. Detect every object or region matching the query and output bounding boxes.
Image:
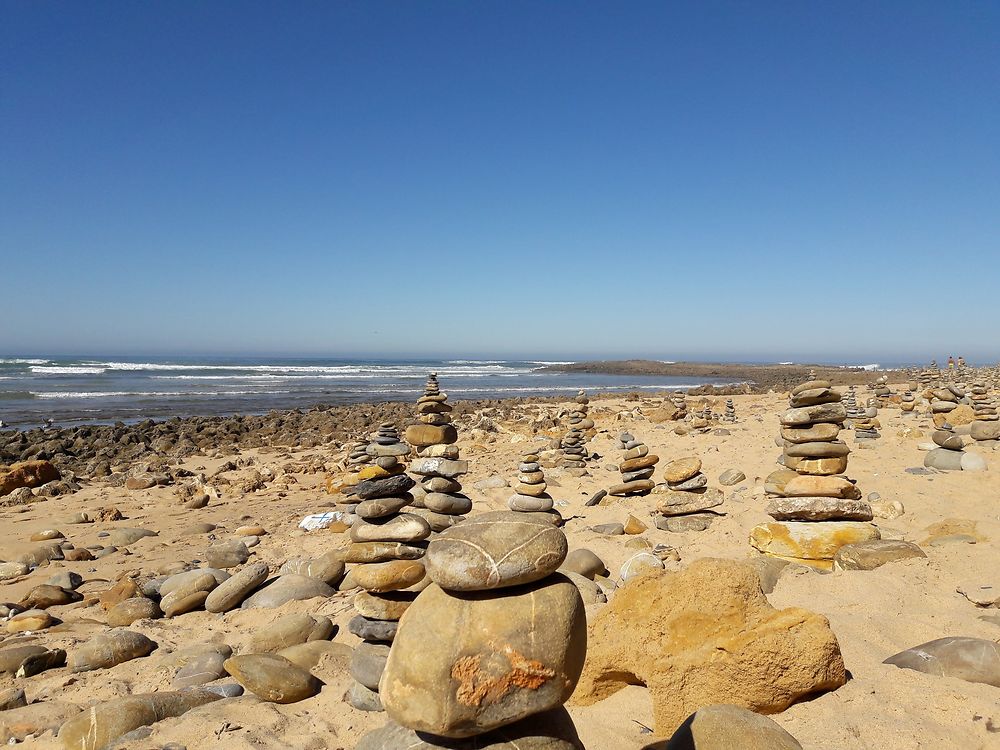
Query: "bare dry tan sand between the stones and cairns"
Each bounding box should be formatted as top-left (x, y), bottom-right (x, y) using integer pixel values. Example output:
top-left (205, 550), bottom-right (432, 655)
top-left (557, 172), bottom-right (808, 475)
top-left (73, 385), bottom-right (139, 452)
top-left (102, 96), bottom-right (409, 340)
top-left (0, 394), bottom-right (1000, 750)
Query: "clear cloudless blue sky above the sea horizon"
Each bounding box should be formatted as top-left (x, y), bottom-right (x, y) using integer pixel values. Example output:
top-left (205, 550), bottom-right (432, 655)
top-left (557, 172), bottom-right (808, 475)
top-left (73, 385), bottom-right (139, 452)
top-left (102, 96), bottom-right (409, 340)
top-left (0, 0), bottom-right (1000, 361)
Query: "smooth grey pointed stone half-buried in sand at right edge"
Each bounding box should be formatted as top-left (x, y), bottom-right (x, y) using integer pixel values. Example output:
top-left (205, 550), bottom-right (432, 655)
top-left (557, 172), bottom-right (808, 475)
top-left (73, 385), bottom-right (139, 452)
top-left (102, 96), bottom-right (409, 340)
top-left (883, 637), bottom-right (1000, 687)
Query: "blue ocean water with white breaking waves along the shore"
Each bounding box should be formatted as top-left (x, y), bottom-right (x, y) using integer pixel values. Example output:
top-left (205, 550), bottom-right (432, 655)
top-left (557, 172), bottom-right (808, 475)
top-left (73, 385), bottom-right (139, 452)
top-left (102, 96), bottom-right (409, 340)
top-left (0, 357), bottom-right (733, 428)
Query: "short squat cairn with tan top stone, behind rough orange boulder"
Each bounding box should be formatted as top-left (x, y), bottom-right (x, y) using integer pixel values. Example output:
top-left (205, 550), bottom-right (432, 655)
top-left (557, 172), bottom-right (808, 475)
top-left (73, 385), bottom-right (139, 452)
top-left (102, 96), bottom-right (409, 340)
top-left (656, 457), bottom-right (725, 532)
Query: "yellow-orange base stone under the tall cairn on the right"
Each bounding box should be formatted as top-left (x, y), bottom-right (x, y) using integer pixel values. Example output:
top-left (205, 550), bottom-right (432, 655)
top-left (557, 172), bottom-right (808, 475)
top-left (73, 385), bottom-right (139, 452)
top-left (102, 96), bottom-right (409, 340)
top-left (750, 521), bottom-right (881, 568)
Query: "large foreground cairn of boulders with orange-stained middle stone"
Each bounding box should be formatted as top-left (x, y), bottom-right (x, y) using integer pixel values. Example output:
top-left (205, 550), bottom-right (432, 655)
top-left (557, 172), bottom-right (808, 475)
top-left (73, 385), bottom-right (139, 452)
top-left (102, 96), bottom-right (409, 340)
top-left (357, 511), bottom-right (587, 750)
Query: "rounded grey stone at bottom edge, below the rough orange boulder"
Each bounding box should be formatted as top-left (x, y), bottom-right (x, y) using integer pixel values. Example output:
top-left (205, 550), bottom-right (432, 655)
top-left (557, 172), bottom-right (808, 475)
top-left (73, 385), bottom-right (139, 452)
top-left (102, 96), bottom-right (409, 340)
top-left (657, 704), bottom-right (802, 750)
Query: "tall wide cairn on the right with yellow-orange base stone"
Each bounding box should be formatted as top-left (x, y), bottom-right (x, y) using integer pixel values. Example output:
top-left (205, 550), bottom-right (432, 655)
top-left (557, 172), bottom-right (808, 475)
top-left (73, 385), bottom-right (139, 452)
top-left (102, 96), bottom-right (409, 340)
top-left (750, 380), bottom-right (881, 570)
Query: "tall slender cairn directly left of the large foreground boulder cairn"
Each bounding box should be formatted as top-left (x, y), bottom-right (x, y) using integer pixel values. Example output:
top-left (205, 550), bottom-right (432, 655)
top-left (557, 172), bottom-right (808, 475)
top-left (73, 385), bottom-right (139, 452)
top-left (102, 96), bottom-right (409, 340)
top-left (341, 423), bottom-right (431, 711)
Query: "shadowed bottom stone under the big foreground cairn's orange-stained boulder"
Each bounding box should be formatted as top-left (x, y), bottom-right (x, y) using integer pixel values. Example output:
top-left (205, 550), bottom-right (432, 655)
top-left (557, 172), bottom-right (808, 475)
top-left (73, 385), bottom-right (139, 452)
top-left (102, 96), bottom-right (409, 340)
top-left (356, 708), bottom-right (583, 750)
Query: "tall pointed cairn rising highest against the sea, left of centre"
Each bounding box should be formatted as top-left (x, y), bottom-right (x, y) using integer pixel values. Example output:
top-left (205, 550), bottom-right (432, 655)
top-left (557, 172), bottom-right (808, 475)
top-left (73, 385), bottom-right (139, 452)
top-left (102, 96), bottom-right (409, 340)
top-left (406, 373), bottom-right (472, 531)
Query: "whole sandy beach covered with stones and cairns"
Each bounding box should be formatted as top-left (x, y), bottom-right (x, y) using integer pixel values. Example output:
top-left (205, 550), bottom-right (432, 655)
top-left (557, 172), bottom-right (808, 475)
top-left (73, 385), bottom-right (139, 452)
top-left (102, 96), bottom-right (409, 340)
top-left (0, 366), bottom-right (1000, 750)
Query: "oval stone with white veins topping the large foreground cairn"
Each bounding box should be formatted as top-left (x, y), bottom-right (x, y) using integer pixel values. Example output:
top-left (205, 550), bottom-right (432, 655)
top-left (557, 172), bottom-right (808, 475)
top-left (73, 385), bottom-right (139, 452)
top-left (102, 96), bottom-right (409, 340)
top-left (425, 511), bottom-right (568, 591)
